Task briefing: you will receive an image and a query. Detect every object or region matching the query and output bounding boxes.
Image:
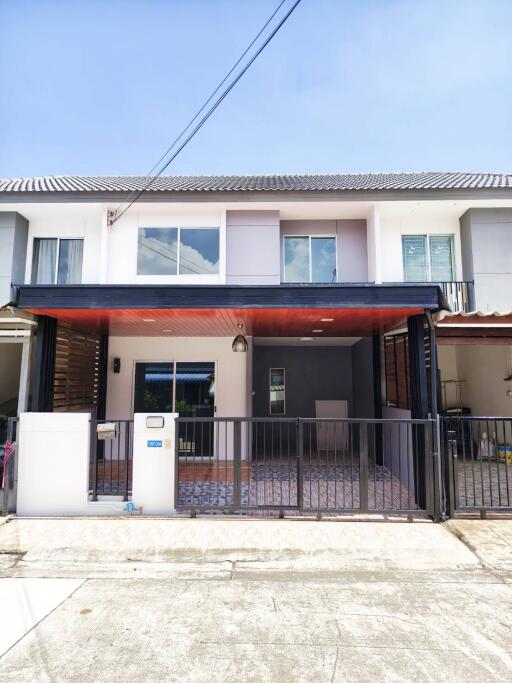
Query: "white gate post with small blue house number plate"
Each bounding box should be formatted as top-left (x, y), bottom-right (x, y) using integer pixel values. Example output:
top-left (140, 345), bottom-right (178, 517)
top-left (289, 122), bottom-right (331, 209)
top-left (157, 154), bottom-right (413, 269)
top-left (132, 413), bottom-right (178, 515)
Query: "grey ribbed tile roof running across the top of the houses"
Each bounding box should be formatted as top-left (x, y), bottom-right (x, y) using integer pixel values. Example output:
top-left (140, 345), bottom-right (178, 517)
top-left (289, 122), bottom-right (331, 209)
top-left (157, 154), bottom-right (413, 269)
top-left (0, 171), bottom-right (512, 193)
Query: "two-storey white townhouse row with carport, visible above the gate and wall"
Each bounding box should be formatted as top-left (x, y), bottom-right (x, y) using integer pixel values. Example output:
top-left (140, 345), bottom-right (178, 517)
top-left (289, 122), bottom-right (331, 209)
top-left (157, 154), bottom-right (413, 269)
top-left (0, 173), bottom-right (512, 516)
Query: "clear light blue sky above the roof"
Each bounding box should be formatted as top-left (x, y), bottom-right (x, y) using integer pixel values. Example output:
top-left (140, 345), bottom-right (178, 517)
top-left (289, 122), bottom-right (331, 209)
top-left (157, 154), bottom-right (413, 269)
top-left (0, 0), bottom-right (512, 177)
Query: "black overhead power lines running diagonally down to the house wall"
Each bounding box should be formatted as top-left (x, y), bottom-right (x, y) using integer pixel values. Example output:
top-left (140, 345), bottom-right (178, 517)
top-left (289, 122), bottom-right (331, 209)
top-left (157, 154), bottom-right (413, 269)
top-left (109, 0), bottom-right (301, 226)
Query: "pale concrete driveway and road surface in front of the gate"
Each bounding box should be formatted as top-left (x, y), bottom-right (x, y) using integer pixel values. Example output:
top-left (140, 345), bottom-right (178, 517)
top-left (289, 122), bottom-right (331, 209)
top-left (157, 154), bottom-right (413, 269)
top-left (0, 519), bottom-right (512, 682)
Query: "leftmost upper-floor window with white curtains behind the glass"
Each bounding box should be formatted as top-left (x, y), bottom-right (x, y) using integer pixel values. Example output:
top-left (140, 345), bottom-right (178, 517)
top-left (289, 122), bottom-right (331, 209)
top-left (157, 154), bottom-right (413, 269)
top-left (31, 237), bottom-right (84, 285)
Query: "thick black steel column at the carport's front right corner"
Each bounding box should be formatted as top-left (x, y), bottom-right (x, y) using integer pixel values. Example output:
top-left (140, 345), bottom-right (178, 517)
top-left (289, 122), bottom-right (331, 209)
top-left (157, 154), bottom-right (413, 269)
top-left (407, 315), bottom-right (428, 510)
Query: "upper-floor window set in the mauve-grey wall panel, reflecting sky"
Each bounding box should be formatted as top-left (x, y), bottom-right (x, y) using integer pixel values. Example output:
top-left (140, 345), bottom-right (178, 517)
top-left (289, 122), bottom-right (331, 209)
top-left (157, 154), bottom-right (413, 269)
top-left (284, 235), bottom-right (336, 283)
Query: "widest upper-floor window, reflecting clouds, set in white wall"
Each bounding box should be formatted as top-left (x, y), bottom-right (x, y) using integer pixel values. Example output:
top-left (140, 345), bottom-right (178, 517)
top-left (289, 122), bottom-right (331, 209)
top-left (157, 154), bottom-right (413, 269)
top-left (137, 228), bottom-right (219, 275)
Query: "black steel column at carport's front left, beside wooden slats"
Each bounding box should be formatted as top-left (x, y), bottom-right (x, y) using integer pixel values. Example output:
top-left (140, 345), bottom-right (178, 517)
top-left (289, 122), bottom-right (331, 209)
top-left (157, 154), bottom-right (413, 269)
top-left (30, 315), bottom-right (57, 413)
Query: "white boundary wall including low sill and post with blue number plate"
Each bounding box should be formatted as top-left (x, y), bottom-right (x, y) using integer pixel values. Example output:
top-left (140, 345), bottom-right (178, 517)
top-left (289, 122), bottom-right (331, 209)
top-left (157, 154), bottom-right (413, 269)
top-left (17, 413), bottom-right (180, 517)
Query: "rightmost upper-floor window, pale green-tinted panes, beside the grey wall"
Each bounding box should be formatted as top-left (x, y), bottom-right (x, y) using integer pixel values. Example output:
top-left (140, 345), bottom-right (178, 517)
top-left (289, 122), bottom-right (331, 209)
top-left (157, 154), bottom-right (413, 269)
top-left (402, 235), bottom-right (455, 282)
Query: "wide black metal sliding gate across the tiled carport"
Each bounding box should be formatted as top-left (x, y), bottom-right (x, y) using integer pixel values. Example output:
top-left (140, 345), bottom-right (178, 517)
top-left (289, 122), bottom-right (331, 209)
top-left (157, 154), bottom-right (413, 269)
top-left (175, 417), bottom-right (443, 517)
